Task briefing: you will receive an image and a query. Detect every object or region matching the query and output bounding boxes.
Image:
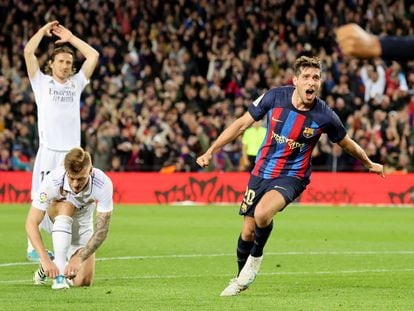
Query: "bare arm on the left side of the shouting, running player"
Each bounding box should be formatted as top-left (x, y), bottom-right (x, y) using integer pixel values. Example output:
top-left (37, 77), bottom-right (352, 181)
top-left (196, 112), bottom-right (255, 167)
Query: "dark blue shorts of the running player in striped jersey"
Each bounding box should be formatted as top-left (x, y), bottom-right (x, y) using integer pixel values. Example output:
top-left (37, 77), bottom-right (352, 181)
top-left (239, 175), bottom-right (309, 217)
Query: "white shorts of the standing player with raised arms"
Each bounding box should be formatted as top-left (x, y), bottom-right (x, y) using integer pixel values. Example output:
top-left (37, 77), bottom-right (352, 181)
top-left (31, 146), bottom-right (67, 200)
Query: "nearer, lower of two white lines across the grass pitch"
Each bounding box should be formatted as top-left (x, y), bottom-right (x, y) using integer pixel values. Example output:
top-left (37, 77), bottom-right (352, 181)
top-left (0, 268), bottom-right (414, 284)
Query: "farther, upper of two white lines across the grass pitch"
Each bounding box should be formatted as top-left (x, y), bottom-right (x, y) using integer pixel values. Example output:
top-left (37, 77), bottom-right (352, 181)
top-left (0, 250), bottom-right (414, 268)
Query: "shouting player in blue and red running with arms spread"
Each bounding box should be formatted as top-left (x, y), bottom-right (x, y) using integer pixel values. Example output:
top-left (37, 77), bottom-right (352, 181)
top-left (197, 56), bottom-right (384, 296)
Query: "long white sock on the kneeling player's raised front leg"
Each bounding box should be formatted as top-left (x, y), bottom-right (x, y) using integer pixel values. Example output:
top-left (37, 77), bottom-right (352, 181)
top-left (52, 215), bottom-right (73, 275)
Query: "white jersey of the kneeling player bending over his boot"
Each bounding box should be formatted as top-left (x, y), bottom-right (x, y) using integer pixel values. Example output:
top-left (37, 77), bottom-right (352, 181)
top-left (32, 167), bottom-right (113, 224)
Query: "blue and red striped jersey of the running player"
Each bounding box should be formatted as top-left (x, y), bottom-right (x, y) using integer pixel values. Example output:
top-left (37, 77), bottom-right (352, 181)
top-left (248, 86), bottom-right (346, 180)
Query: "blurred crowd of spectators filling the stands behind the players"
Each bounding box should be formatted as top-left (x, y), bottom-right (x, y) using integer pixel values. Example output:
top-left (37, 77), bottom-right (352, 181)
top-left (0, 0), bottom-right (414, 172)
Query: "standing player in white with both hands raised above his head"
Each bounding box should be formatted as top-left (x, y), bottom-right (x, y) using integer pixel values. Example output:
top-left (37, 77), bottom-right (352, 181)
top-left (24, 21), bottom-right (99, 261)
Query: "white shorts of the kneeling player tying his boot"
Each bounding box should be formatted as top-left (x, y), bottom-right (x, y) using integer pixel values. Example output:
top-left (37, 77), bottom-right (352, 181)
top-left (39, 213), bottom-right (93, 261)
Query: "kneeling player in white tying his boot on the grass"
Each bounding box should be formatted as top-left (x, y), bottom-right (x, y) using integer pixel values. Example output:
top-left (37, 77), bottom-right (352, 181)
top-left (26, 147), bottom-right (113, 289)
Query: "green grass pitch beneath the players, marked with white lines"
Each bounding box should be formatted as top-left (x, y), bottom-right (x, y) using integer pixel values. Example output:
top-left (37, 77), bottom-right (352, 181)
top-left (0, 204), bottom-right (414, 311)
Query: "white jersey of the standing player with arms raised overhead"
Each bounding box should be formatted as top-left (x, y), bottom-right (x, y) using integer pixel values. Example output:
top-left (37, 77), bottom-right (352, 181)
top-left (30, 70), bottom-right (89, 151)
